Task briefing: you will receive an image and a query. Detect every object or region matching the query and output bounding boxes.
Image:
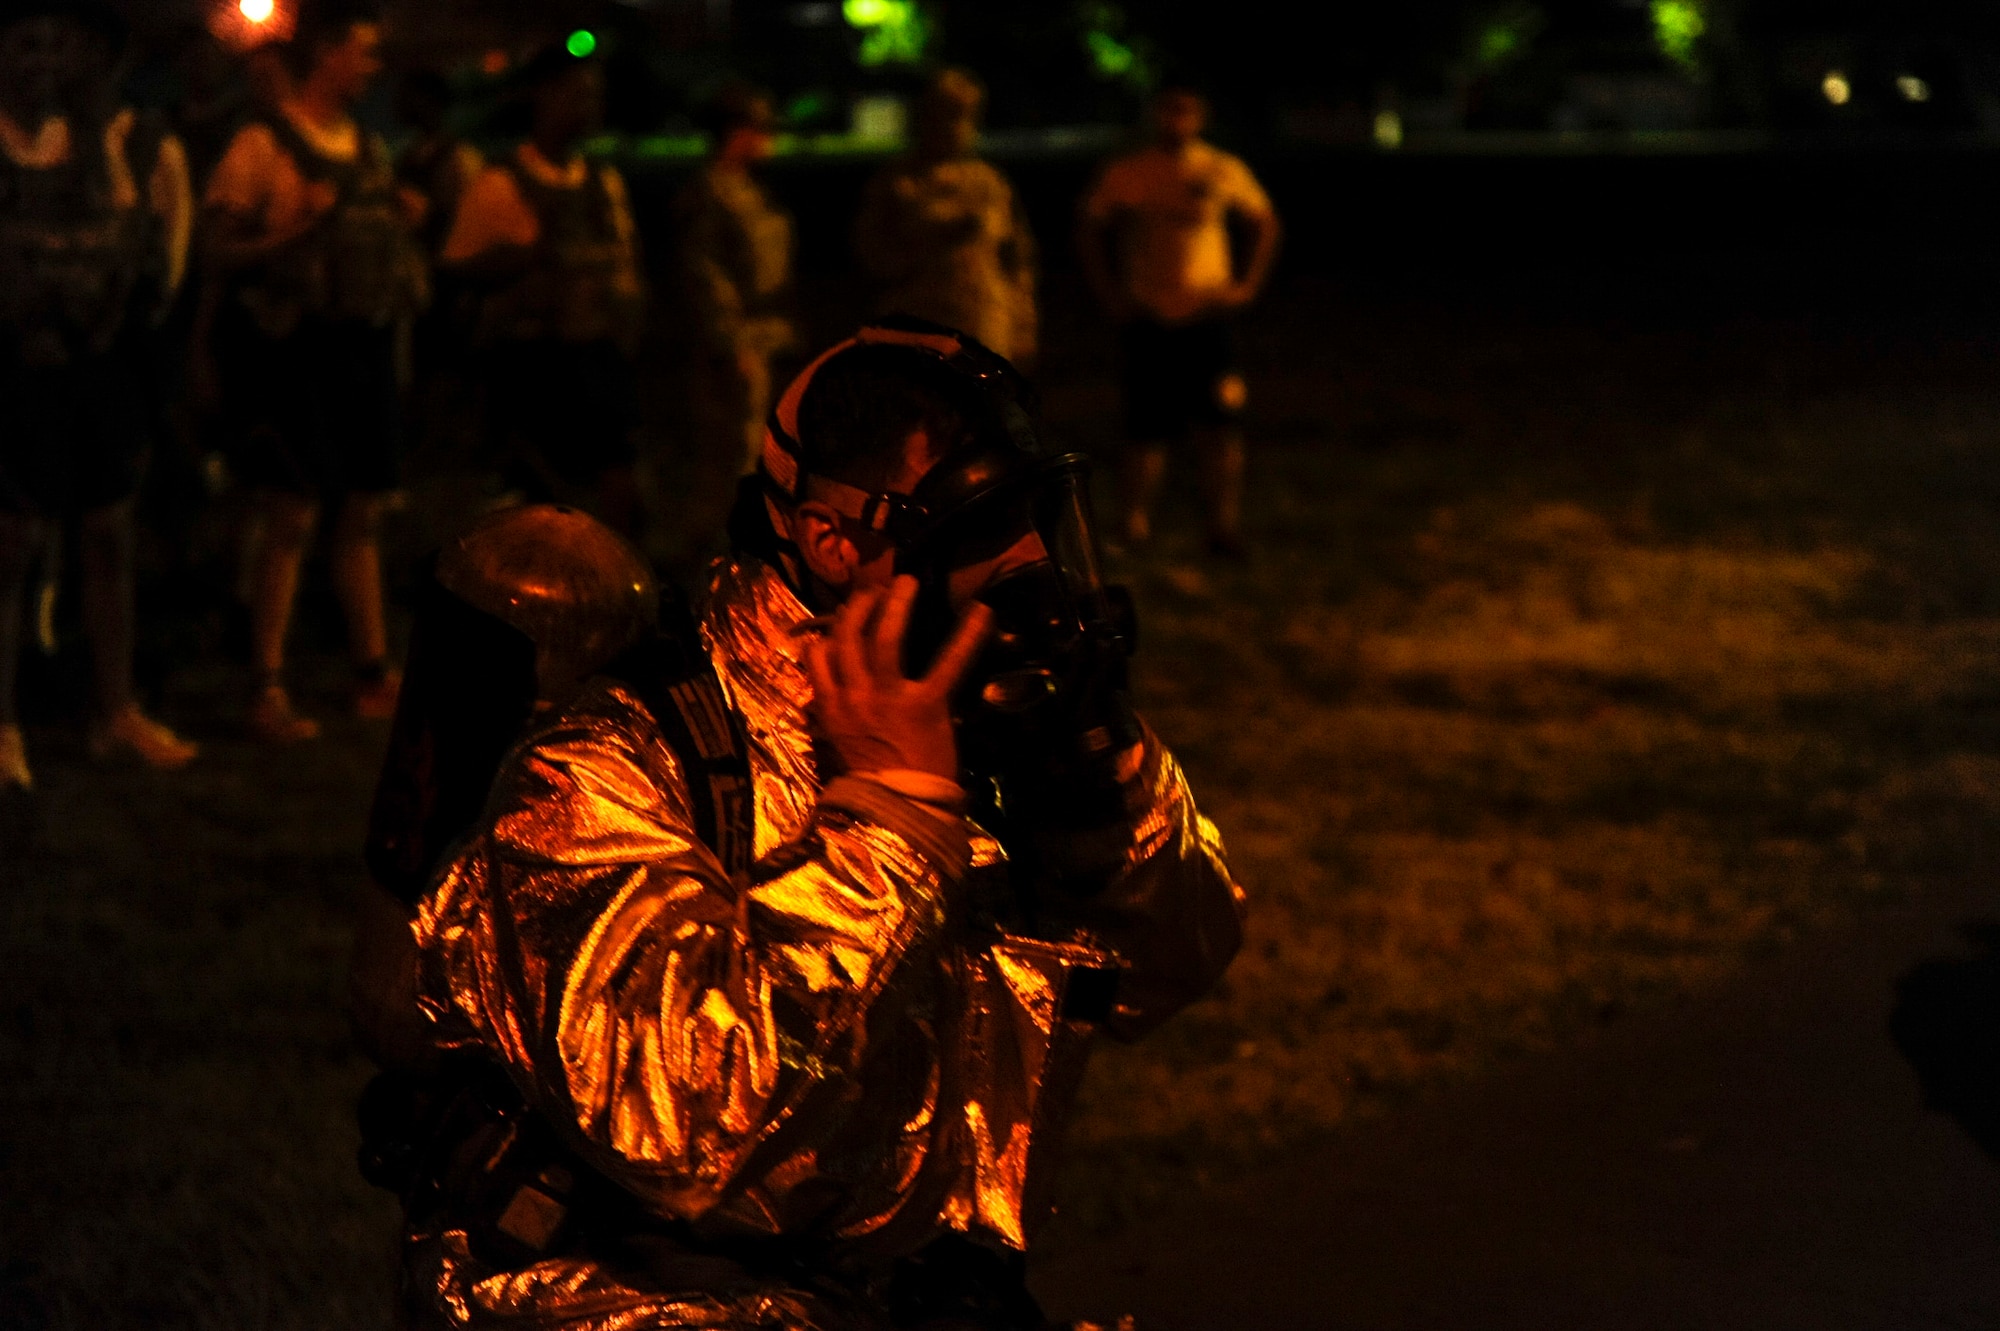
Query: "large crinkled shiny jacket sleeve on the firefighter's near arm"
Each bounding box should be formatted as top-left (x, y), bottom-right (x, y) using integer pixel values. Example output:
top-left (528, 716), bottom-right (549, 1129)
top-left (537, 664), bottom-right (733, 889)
top-left (416, 711), bottom-right (970, 1219)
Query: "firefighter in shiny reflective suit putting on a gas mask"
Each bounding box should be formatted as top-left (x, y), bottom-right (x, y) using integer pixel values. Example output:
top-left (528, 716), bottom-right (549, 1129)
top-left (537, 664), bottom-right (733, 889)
top-left (362, 326), bottom-right (1242, 1331)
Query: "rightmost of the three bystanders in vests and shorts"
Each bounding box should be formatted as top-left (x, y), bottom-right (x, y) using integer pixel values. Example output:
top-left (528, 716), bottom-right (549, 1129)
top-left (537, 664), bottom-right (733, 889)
top-left (442, 46), bottom-right (646, 534)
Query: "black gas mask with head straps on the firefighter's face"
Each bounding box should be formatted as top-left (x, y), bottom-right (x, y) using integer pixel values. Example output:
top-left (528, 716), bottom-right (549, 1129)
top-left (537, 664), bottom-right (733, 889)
top-left (762, 320), bottom-right (1140, 853)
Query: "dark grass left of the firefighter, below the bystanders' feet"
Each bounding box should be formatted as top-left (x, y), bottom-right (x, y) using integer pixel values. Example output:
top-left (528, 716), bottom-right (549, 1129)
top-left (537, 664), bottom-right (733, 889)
top-left (0, 671), bottom-right (396, 1331)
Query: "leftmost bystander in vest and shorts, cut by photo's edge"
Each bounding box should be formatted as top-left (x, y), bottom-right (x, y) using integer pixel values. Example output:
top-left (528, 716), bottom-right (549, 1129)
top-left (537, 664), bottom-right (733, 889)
top-left (0, 0), bottom-right (198, 789)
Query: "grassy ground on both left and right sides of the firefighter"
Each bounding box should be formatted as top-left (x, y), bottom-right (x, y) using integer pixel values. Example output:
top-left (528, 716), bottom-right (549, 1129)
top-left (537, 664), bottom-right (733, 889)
top-left (0, 263), bottom-right (2000, 1331)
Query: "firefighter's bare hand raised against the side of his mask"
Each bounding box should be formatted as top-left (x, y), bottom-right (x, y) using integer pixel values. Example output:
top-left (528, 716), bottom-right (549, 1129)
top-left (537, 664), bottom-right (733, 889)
top-left (806, 578), bottom-right (992, 781)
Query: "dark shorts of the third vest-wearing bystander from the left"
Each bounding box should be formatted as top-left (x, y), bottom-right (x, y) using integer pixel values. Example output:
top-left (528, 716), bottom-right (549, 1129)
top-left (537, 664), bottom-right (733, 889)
top-left (486, 338), bottom-right (638, 488)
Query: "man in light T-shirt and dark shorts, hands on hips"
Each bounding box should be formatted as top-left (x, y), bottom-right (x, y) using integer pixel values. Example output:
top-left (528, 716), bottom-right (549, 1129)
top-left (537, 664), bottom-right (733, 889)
top-left (1078, 86), bottom-right (1280, 558)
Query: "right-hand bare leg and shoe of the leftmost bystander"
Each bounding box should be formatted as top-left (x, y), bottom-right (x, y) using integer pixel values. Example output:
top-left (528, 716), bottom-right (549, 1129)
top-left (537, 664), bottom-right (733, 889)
top-left (78, 500), bottom-right (200, 767)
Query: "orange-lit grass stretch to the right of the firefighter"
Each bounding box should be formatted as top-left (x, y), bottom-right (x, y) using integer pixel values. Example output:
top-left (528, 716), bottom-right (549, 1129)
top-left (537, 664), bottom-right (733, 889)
top-left (1040, 297), bottom-right (2000, 1227)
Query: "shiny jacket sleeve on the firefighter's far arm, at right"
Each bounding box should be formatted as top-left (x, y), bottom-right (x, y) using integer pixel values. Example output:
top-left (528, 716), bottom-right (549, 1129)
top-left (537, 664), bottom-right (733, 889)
top-left (1050, 727), bottom-right (1244, 1039)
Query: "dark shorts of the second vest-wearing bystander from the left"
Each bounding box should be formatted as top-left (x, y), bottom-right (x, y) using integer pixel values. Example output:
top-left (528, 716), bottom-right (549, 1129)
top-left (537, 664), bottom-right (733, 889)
top-left (216, 318), bottom-right (402, 500)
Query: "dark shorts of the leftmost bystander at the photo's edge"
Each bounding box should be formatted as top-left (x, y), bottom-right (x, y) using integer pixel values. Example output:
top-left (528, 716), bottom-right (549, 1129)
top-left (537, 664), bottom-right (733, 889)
top-left (0, 352), bottom-right (152, 518)
